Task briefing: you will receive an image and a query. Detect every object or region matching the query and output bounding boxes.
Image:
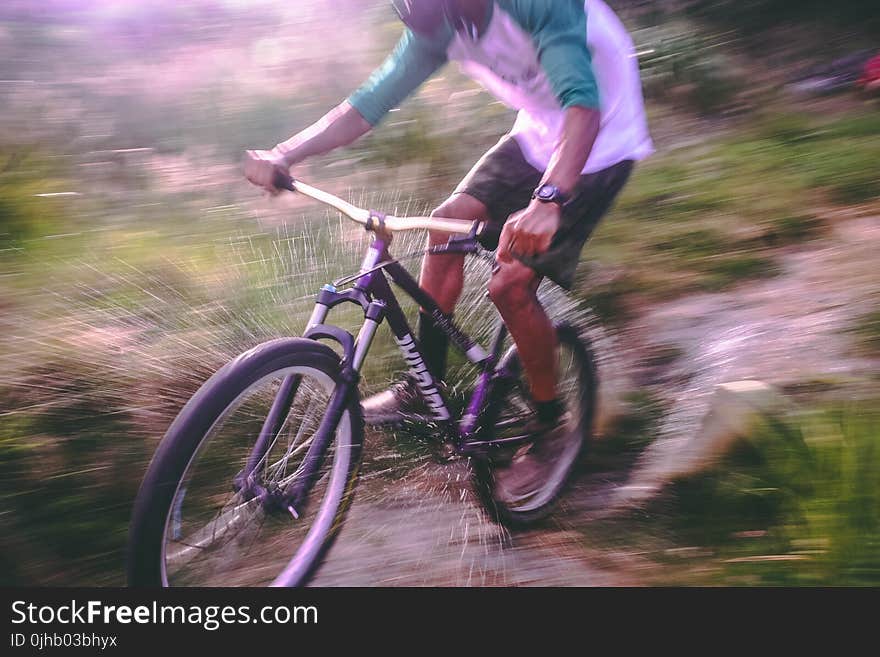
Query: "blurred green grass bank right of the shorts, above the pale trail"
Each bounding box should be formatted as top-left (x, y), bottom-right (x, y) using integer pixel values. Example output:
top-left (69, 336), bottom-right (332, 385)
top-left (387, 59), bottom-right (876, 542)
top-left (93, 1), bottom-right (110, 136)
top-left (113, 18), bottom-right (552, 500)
top-left (587, 112), bottom-right (880, 300)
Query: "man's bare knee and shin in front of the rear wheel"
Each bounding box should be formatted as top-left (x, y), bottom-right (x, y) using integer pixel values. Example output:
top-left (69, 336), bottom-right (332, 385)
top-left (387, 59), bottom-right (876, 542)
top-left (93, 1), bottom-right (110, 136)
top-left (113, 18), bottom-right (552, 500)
top-left (489, 260), bottom-right (561, 422)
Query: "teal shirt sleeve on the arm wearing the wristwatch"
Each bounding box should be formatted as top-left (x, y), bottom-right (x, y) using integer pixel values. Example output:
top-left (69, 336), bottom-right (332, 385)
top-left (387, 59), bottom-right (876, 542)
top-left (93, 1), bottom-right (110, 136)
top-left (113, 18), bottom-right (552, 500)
top-left (517, 0), bottom-right (599, 109)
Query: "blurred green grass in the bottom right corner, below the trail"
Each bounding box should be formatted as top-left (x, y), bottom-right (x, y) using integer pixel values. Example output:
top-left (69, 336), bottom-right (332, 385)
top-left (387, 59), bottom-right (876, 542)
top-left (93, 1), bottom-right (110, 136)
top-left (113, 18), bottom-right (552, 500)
top-left (671, 403), bottom-right (880, 586)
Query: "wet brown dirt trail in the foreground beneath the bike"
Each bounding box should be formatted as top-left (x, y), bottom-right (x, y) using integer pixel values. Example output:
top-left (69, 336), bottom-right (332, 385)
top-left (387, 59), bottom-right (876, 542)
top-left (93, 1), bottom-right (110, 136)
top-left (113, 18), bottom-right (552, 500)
top-left (313, 448), bottom-right (640, 586)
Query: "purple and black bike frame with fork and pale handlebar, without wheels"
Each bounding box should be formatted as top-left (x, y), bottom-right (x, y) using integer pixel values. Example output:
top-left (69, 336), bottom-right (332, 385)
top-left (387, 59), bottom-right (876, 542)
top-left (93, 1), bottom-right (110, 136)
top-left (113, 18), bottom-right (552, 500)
top-left (235, 174), bottom-right (530, 517)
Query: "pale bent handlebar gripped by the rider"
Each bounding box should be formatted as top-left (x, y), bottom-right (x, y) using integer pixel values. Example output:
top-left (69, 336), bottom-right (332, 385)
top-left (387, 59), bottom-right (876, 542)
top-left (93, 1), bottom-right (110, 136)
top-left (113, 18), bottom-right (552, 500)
top-left (272, 170), bottom-right (485, 237)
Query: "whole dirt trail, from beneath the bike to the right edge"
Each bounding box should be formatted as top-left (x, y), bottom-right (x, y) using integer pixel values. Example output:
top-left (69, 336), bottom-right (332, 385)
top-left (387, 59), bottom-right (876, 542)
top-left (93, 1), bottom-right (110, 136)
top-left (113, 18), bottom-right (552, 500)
top-left (314, 218), bottom-right (880, 586)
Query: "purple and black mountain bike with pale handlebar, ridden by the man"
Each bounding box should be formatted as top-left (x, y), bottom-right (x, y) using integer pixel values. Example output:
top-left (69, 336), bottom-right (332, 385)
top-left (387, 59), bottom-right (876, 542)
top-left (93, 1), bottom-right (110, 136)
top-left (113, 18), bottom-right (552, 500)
top-left (128, 174), bottom-right (597, 586)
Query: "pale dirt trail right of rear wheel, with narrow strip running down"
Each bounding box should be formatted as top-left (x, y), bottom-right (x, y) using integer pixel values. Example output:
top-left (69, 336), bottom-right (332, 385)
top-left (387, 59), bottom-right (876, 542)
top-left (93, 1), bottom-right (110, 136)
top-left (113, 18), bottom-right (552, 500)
top-left (614, 217), bottom-right (880, 506)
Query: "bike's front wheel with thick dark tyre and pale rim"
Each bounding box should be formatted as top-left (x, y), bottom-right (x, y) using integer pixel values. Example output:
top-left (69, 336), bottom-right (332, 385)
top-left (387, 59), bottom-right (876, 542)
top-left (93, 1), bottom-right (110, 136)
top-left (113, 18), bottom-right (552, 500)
top-left (128, 338), bottom-right (363, 586)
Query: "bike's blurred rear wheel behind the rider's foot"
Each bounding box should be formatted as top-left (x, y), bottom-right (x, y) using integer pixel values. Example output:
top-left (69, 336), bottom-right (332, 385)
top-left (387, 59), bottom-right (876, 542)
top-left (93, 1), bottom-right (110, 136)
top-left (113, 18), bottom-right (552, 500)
top-left (471, 324), bottom-right (598, 527)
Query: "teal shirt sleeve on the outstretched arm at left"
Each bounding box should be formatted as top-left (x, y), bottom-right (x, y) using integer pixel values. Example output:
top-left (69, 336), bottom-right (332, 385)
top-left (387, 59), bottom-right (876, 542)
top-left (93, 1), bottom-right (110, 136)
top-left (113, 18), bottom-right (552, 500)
top-left (348, 30), bottom-right (446, 125)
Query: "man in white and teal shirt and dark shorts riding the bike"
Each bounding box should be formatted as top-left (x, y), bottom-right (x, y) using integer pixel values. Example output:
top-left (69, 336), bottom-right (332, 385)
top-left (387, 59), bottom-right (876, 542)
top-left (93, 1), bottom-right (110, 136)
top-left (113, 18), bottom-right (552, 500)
top-left (245, 0), bottom-right (652, 476)
